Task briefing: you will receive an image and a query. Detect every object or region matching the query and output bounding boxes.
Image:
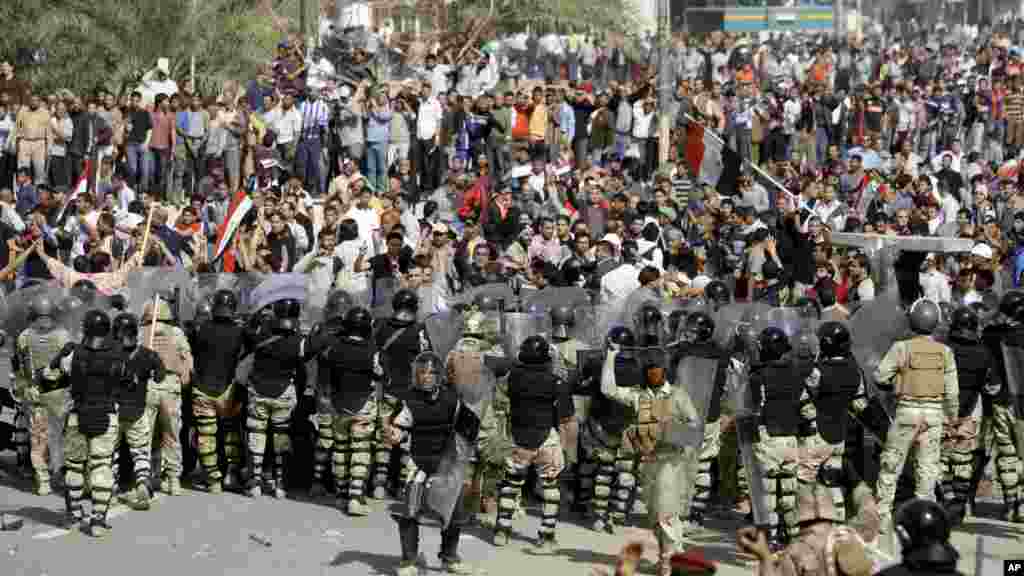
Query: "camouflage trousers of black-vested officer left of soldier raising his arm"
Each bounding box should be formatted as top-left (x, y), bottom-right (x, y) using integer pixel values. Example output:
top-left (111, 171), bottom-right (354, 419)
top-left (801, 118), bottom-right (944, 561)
top-left (495, 428), bottom-right (565, 540)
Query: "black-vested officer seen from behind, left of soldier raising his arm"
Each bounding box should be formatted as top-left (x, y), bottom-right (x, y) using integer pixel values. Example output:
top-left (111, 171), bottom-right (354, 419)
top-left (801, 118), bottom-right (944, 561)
top-left (495, 335), bottom-right (573, 551)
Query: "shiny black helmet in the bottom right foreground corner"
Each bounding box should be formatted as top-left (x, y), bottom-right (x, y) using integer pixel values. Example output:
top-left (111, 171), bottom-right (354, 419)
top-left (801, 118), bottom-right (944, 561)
top-left (893, 498), bottom-right (959, 566)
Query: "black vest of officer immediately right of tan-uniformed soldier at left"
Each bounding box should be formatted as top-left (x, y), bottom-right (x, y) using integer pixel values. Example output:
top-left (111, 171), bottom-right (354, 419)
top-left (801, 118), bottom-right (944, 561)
top-left (193, 320), bottom-right (246, 397)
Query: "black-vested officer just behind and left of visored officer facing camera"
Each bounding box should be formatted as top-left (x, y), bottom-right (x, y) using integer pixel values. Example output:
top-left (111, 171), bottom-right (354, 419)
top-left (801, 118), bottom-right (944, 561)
top-left (373, 289), bottom-right (430, 499)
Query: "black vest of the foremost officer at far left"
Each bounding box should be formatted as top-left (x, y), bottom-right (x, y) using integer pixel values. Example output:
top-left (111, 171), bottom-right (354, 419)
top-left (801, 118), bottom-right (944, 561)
top-left (71, 346), bottom-right (126, 438)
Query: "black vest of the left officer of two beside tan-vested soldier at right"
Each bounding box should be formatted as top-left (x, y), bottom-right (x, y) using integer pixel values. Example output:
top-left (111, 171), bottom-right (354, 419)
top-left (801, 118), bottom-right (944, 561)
top-left (751, 360), bottom-right (804, 436)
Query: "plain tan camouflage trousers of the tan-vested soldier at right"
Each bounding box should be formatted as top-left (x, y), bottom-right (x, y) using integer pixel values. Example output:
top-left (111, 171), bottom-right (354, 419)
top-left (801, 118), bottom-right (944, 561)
top-left (878, 401), bottom-right (945, 531)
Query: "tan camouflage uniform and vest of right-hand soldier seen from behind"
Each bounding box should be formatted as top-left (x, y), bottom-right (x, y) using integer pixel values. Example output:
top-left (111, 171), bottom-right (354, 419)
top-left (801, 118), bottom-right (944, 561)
top-left (874, 336), bottom-right (959, 531)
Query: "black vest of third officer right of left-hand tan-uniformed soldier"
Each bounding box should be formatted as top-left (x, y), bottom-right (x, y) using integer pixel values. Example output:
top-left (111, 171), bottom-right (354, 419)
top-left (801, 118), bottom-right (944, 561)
top-left (321, 337), bottom-right (377, 414)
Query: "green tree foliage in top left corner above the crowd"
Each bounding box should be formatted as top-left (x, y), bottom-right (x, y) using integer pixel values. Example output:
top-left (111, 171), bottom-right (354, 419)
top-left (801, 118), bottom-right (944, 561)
top-left (0, 0), bottom-right (280, 93)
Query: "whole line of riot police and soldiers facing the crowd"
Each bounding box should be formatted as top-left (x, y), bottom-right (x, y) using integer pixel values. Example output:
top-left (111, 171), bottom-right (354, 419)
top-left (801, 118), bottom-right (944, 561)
top-left (13, 282), bottom-right (1024, 576)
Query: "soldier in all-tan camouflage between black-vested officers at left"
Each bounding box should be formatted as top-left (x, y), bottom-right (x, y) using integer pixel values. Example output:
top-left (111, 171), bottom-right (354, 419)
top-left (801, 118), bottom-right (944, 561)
top-left (141, 301), bottom-right (193, 495)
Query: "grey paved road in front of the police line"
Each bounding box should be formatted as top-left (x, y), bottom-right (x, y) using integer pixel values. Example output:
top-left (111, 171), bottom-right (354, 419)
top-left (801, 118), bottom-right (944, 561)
top-left (0, 461), bottom-right (1024, 576)
